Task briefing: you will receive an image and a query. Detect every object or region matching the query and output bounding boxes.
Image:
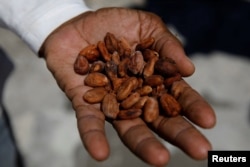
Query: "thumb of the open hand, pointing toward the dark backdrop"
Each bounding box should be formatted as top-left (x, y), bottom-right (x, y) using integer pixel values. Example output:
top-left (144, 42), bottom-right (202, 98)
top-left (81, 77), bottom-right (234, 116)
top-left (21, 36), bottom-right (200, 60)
top-left (155, 30), bottom-right (195, 77)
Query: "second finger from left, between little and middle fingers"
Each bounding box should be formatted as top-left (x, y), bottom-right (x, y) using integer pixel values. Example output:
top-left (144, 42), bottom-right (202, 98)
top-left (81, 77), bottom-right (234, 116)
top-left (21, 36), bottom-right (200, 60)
top-left (113, 118), bottom-right (169, 166)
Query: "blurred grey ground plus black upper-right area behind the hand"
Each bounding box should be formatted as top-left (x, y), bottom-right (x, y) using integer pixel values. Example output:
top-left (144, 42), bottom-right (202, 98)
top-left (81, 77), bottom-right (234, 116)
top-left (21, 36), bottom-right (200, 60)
top-left (0, 0), bottom-right (250, 167)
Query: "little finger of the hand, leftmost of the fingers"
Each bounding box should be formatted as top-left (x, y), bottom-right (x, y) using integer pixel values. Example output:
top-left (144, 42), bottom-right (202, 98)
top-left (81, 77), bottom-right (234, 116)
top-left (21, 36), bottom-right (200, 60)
top-left (68, 87), bottom-right (109, 161)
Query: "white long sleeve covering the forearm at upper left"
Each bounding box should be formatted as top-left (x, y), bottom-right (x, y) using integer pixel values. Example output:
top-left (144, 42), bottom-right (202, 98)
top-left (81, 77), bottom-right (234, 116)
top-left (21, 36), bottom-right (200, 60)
top-left (0, 0), bottom-right (89, 53)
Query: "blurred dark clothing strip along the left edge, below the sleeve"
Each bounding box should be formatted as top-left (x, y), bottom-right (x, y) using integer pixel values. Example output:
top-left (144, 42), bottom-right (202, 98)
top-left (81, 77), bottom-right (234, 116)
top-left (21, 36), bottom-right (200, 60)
top-left (0, 48), bottom-right (24, 167)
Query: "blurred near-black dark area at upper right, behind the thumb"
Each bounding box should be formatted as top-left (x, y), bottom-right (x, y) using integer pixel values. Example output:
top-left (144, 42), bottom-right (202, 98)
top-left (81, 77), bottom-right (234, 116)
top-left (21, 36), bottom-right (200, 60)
top-left (137, 0), bottom-right (250, 57)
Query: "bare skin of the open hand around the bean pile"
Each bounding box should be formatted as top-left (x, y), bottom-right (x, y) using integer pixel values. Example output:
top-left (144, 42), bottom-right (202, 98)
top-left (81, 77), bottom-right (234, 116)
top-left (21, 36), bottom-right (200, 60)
top-left (40, 8), bottom-right (215, 166)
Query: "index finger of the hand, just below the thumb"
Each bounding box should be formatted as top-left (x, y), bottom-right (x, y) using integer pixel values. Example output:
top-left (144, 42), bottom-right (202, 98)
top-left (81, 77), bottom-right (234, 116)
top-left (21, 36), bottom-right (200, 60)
top-left (171, 80), bottom-right (216, 128)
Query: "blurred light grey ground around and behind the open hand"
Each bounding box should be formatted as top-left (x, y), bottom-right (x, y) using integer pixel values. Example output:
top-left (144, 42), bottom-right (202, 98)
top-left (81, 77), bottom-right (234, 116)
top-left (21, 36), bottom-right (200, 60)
top-left (0, 0), bottom-right (250, 167)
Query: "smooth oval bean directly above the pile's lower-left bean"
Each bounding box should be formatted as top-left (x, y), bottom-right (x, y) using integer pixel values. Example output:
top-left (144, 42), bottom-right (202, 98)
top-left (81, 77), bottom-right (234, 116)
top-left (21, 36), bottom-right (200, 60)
top-left (84, 72), bottom-right (109, 87)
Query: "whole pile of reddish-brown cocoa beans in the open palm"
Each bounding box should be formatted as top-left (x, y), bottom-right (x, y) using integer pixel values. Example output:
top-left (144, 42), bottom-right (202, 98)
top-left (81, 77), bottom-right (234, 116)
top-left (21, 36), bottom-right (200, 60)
top-left (74, 32), bottom-right (182, 123)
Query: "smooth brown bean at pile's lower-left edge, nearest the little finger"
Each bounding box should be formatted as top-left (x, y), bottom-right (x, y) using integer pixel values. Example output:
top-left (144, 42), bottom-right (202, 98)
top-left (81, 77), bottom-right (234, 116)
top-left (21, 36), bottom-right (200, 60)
top-left (83, 87), bottom-right (108, 104)
